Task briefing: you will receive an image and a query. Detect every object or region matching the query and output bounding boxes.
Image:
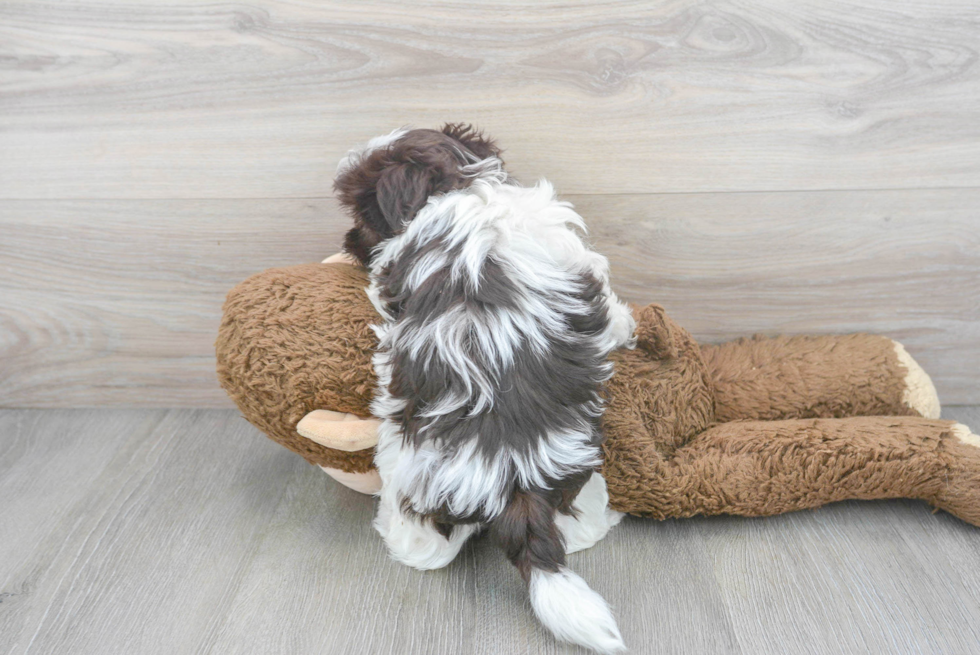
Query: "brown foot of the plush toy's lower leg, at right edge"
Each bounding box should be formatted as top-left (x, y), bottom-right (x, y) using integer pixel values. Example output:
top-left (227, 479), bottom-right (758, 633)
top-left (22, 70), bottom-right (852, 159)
top-left (936, 423), bottom-right (980, 527)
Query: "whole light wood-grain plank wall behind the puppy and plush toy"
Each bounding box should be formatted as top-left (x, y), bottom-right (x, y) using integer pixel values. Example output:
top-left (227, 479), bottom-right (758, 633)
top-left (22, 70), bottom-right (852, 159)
top-left (0, 0), bottom-right (980, 407)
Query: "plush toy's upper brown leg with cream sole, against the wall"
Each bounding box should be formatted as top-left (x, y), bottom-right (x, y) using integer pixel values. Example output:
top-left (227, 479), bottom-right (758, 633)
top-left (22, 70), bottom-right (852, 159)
top-left (702, 334), bottom-right (939, 421)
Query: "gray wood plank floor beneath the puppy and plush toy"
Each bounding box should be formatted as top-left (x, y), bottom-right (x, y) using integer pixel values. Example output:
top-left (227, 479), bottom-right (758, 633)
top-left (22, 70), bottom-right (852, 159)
top-left (0, 407), bottom-right (980, 655)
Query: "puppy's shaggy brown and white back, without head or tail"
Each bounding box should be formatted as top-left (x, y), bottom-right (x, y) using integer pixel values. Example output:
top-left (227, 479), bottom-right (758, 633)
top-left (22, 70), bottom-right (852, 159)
top-left (372, 181), bottom-right (610, 523)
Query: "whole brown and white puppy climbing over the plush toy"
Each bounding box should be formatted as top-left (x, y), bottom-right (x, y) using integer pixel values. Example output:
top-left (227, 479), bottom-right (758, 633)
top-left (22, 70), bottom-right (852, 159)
top-left (335, 125), bottom-right (634, 653)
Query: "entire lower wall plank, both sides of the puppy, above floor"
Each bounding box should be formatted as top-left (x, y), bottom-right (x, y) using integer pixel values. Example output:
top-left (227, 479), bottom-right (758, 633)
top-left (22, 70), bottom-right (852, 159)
top-left (0, 189), bottom-right (980, 407)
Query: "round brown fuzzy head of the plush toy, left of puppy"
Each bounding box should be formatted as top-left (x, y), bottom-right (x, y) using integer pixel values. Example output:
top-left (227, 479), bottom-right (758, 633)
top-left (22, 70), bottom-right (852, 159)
top-left (216, 264), bottom-right (378, 473)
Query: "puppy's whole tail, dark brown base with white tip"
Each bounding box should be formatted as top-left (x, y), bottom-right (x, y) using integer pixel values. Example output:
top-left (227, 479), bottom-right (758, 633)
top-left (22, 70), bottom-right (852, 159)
top-left (491, 490), bottom-right (626, 653)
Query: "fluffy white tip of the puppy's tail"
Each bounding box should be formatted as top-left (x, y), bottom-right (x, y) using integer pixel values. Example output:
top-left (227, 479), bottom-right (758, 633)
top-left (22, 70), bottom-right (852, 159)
top-left (530, 568), bottom-right (626, 653)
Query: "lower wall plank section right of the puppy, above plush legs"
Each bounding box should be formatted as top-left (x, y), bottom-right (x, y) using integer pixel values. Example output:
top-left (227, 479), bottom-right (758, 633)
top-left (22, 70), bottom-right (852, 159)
top-left (576, 190), bottom-right (980, 404)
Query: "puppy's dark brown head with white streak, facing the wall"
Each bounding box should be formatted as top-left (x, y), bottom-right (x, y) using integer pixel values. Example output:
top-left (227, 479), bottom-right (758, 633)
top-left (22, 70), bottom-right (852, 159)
top-left (334, 123), bottom-right (500, 266)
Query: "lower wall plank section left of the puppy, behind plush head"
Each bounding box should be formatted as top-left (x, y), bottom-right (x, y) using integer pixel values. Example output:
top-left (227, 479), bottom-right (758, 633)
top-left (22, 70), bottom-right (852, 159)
top-left (0, 200), bottom-right (346, 407)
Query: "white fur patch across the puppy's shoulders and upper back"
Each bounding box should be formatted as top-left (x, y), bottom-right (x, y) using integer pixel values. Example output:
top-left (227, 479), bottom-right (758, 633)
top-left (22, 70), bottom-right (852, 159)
top-left (368, 177), bottom-right (635, 412)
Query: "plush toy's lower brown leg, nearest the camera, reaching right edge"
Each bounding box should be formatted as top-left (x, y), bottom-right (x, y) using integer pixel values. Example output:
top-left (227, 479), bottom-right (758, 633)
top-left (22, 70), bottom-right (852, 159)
top-left (603, 417), bottom-right (980, 526)
